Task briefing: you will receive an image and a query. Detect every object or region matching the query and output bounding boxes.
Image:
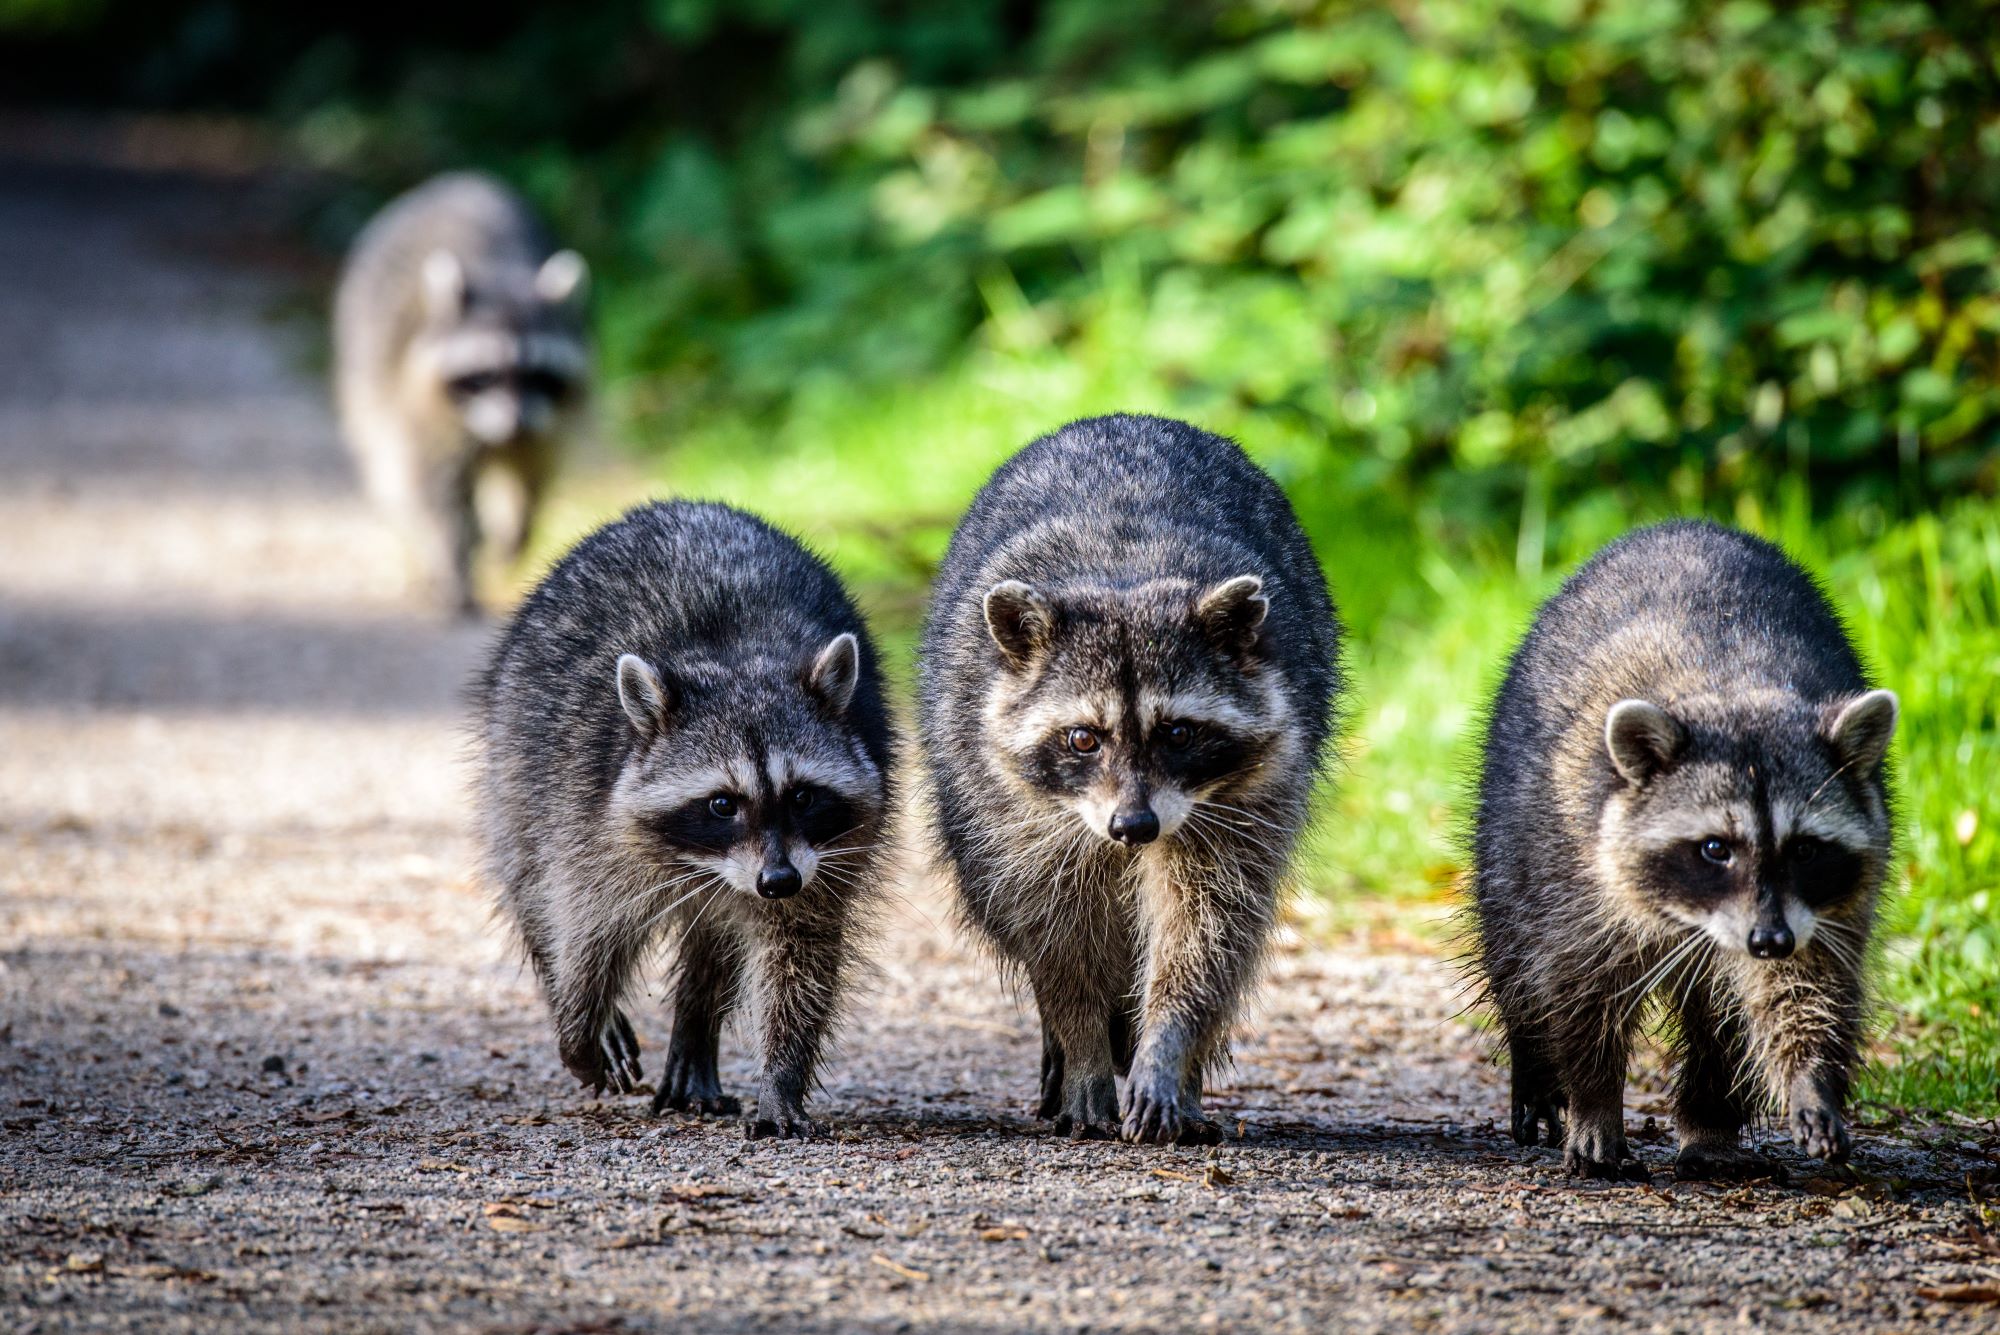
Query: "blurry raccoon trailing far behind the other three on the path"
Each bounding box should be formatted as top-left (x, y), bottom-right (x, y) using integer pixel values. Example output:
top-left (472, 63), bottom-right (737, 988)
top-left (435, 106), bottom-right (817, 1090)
top-left (334, 172), bottom-right (590, 614)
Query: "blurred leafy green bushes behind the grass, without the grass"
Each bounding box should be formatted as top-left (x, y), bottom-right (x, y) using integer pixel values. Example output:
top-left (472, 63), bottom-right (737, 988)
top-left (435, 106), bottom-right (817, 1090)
top-left (15, 0), bottom-right (2000, 522)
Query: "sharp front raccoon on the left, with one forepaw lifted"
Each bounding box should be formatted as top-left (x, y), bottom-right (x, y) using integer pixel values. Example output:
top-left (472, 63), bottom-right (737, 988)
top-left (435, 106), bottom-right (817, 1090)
top-left (474, 502), bottom-right (892, 1137)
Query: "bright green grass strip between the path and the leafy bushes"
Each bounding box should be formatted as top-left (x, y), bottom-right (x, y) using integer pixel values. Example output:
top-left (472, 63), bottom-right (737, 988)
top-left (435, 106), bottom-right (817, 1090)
top-left (552, 331), bottom-right (2000, 1115)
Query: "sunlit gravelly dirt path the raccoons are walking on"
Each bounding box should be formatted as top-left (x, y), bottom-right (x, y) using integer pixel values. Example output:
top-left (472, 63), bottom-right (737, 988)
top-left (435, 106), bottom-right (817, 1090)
top-left (0, 158), bottom-right (2000, 1333)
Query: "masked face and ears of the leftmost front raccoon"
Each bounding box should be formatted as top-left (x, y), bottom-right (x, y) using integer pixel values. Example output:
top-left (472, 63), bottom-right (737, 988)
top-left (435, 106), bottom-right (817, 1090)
top-left (612, 634), bottom-right (884, 899)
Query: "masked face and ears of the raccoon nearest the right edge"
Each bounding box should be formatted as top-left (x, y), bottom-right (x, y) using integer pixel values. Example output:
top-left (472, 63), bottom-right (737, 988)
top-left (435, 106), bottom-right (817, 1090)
top-left (1598, 691), bottom-right (1896, 959)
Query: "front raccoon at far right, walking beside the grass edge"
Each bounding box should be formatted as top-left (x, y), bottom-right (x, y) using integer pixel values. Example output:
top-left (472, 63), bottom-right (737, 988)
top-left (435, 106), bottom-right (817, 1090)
top-left (1472, 522), bottom-right (1896, 1179)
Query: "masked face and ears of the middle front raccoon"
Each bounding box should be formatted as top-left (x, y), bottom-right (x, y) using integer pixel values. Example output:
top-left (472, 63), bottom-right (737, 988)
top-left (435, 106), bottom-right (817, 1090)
top-left (986, 576), bottom-right (1290, 847)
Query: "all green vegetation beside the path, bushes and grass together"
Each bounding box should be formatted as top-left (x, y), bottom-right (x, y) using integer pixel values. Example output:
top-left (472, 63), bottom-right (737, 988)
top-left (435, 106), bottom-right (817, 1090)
top-left (0, 0), bottom-right (2000, 1113)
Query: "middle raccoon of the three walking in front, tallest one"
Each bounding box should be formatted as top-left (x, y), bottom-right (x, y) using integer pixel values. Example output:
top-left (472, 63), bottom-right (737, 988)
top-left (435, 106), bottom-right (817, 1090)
top-left (918, 416), bottom-right (1340, 1143)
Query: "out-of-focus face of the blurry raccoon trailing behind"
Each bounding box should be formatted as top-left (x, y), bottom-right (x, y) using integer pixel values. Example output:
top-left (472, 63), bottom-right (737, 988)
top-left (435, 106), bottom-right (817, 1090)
top-left (412, 250), bottom-right (590, 446)
